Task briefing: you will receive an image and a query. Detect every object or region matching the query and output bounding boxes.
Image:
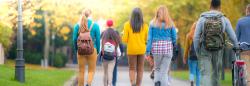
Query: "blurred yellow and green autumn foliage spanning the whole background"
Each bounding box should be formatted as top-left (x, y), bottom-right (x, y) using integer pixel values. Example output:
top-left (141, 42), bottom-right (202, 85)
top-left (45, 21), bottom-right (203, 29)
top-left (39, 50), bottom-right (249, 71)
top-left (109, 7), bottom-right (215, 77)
top-left (0, 0), bottom-right (250, 65)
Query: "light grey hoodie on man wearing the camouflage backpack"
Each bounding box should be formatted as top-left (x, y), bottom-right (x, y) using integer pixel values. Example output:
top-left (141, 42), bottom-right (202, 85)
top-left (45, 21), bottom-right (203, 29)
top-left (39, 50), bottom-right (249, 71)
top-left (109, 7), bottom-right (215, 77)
top-left (193, 10), bottom-right (238, 52)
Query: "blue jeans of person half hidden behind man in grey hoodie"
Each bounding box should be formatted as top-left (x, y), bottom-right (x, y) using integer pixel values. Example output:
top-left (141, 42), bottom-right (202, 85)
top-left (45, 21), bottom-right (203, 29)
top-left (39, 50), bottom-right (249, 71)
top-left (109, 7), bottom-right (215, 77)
top-left (188, 59), bottom-right (200, 86)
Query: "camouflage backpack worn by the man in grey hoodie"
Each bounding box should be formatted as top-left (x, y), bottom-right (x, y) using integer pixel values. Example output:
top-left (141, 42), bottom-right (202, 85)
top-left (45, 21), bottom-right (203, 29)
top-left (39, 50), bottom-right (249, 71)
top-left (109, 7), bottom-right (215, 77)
top-left (200, 15), bottom-right (225, 51)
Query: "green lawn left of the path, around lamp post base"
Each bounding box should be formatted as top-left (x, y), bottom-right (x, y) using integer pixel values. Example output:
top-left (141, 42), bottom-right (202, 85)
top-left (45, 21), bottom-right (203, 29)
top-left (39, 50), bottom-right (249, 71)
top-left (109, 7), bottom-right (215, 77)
top-left (0, 61), bottom-right (74, 86)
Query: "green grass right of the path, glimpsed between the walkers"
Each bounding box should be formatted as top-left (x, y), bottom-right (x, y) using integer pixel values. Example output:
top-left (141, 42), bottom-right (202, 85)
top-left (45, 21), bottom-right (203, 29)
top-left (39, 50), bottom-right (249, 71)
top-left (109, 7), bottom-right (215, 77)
top-left (171, 71), bottom-right (232, 86)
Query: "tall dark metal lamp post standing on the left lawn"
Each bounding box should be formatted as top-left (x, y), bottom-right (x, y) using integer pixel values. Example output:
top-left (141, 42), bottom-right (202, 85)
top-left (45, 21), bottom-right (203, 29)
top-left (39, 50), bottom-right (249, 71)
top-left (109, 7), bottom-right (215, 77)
top-left (15, 0), bottom-right (25, 82)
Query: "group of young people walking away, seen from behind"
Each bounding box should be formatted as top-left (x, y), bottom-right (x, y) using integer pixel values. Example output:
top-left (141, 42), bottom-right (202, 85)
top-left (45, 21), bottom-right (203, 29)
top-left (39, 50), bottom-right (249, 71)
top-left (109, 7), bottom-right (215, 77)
top-left (73, 0), bottom-right (250, 86)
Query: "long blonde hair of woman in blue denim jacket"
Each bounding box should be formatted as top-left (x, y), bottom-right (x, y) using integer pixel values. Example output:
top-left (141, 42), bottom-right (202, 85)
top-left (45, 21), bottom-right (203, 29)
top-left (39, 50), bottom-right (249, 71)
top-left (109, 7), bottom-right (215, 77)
top-left (153, 5), bottom-right (174, 28)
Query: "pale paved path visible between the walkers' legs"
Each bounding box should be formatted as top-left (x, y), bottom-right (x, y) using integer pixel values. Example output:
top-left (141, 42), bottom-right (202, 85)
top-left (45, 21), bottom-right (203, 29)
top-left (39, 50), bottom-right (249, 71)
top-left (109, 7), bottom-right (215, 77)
top-left (64, 67), bottom-right (189, 86)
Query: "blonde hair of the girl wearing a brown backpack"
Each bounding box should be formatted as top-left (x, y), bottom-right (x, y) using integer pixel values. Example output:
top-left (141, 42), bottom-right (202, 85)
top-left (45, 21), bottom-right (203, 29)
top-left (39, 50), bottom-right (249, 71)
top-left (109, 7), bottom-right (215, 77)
top-left (79, 15), bottom-right (89, 32)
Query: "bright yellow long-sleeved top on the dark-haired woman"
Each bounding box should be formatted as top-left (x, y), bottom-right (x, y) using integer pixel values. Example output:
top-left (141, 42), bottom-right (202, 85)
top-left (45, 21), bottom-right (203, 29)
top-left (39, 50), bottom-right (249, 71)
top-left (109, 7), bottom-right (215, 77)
top-left (122, 21), bottom-right (148, 55)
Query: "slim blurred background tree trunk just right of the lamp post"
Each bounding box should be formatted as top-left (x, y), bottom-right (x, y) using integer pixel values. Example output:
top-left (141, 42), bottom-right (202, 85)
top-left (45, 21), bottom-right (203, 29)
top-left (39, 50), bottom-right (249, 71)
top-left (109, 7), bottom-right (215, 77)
top-left (43, 12), bottom-right (50, 68)
